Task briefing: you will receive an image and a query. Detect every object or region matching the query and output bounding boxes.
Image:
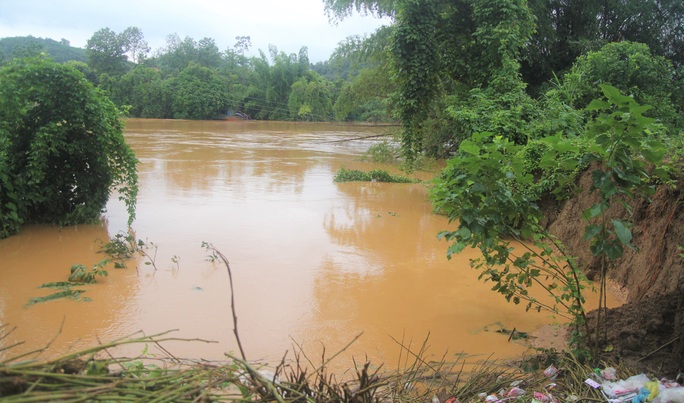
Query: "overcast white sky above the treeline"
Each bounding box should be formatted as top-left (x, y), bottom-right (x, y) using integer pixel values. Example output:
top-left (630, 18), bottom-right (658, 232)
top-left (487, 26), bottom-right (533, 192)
top-left (0, 0), bottom-right (389, 63)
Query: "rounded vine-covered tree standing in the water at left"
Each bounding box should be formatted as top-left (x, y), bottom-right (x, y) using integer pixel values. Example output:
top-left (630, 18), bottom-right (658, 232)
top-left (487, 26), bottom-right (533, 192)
top-left (0, 58), bottom-right (137, 237)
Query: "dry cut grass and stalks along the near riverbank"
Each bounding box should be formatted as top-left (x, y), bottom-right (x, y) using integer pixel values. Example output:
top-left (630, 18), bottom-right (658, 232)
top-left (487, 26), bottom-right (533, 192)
top-left (0, 325), bottom-right (631, 403)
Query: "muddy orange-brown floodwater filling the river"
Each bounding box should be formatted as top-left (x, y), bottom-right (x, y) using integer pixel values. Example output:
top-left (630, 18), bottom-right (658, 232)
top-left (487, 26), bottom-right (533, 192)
top-left (0, 119), bottom-right (617, 376)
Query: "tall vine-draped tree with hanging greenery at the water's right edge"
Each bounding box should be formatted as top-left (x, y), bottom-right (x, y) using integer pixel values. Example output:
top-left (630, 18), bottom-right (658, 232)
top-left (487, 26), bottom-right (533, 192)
top-left (392, 0), bottom-right (534, 163)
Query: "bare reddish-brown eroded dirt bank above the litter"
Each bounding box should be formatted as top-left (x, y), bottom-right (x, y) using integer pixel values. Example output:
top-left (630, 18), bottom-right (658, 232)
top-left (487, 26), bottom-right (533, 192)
top-left (549, 172), bottom-right (684, 376)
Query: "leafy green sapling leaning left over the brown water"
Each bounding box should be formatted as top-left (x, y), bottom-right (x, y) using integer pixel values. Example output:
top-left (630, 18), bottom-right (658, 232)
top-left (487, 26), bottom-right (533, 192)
top-left (430, 133), bottom-right (588, 356)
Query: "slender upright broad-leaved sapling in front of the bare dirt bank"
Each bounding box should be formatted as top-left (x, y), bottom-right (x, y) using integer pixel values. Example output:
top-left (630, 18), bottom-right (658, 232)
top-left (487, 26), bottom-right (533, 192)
top-left (543, 84), bottom-right (668, 351)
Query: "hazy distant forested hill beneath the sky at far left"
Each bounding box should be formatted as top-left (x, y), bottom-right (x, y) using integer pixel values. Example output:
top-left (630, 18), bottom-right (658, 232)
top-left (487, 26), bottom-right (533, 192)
top-left (0, 36), bottom-right (86, 63)
